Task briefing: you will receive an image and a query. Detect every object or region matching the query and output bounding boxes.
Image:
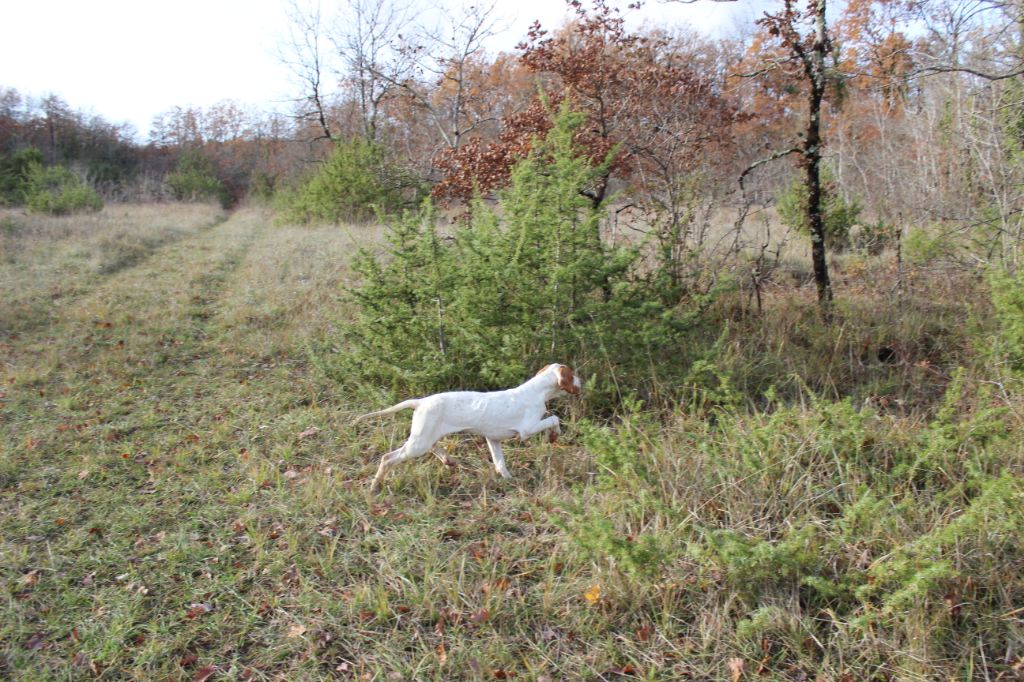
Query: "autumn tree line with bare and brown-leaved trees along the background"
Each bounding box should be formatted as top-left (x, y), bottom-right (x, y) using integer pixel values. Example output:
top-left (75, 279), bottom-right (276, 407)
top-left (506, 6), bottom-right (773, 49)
top-left (0, 0), bottom-right (1024, 304)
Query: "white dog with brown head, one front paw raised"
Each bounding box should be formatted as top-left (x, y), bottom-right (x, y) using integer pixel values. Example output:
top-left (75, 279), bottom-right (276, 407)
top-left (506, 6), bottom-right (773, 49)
top-left (356, 365), bottom-right (582, 491)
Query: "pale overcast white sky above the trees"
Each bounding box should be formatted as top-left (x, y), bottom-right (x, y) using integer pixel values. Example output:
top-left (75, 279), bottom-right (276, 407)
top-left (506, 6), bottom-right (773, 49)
top-left (0, 0), bottom-right (769, 139)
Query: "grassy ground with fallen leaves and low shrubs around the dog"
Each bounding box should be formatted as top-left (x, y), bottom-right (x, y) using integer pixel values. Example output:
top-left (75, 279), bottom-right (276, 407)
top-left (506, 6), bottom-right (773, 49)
top-left (0, 207), bottom-right (1024, 680)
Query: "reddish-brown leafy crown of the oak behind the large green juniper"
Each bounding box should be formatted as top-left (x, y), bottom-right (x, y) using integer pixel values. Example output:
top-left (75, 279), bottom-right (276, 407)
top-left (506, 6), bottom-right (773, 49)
top-left (434, 0), bottom-right (736, 224)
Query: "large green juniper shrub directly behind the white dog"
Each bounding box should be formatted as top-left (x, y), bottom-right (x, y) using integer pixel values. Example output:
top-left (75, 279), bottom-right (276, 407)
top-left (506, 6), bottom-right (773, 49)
top-left (329, 105), bottom-right (695, 409)
